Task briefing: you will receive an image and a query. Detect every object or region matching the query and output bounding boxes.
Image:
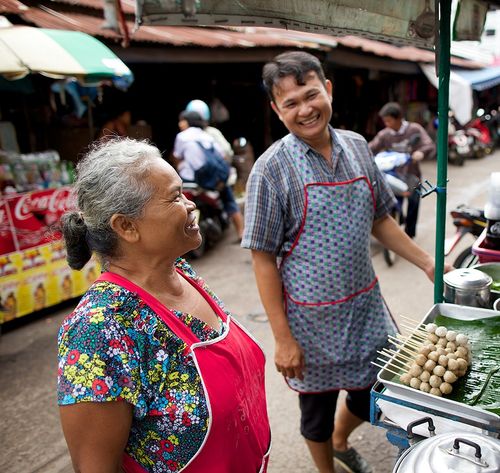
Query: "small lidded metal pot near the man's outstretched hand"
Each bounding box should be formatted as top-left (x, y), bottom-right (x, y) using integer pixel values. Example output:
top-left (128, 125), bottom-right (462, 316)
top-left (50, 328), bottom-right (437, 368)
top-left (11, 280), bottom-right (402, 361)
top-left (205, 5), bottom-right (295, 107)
top-left (443, 268), bottom-right (493, 309)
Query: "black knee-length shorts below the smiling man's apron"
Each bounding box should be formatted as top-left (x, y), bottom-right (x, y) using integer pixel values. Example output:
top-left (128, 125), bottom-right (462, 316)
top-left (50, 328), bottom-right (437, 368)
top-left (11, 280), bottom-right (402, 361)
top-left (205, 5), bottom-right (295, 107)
top-left (299, 386), bottom-right (372, 442)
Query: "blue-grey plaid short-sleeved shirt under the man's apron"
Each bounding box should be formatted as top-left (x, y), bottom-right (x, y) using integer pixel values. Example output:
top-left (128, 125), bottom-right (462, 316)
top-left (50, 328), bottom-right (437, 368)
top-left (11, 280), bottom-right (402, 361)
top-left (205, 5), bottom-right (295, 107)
top-left (241, 127), bottom-right (396, 257)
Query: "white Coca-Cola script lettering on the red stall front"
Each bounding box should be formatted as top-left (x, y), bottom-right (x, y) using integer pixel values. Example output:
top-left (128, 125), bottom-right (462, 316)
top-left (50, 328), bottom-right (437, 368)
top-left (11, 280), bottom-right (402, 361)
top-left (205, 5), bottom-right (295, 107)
top-left (14, 187), bottom-right (74, 220)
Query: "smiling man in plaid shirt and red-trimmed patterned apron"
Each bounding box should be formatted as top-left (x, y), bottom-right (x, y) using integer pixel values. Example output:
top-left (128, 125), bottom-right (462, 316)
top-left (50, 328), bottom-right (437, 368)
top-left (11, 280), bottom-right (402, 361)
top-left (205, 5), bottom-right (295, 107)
top-left (242, 52), bottom-right (446, 473)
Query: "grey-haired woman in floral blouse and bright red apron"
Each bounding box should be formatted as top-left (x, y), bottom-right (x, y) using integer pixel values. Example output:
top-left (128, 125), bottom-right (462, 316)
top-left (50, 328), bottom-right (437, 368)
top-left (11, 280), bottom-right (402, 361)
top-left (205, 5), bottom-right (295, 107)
top-left (58, 138), bottom-right (270, 473)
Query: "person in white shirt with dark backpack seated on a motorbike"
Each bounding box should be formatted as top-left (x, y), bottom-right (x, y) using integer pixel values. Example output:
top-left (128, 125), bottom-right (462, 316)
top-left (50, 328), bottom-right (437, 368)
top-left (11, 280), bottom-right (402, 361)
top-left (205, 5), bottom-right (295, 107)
top-left (172, 111), bottom-right (243, 243)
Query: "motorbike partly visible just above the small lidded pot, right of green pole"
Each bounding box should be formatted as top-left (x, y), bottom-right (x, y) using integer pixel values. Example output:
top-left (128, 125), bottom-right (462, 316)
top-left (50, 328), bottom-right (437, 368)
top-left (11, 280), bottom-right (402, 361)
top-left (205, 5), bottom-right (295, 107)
top-left (444, 205), bottom-right (487, 268)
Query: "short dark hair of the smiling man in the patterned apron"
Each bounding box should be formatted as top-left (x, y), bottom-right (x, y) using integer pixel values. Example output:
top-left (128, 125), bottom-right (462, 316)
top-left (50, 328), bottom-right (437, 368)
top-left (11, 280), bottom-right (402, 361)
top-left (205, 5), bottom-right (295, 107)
top-left (262, 51), bottom-right (326, 102)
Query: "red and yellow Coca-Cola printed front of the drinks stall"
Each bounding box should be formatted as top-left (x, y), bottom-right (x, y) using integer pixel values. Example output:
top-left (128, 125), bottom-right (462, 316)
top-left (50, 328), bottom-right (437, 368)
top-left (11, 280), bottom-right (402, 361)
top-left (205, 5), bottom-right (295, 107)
top-left (0, 186), bottom-right (98, 323)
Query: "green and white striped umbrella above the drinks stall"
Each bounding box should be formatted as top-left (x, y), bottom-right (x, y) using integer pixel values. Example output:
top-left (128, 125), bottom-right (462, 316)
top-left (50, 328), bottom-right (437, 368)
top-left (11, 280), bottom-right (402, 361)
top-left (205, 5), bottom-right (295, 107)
top-left (0, 26), bottom-right (133, 88)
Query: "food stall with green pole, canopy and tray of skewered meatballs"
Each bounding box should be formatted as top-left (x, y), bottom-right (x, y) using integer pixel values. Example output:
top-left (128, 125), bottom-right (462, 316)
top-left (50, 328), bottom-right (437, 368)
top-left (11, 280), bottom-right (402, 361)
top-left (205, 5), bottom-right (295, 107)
top-left (132, 0), bottom-right (500, 466)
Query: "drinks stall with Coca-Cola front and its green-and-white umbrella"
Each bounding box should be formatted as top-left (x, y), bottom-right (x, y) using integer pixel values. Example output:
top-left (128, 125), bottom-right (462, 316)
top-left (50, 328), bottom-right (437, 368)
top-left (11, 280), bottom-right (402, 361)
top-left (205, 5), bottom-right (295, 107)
top-left (0, 26), bottom-right (133, 326)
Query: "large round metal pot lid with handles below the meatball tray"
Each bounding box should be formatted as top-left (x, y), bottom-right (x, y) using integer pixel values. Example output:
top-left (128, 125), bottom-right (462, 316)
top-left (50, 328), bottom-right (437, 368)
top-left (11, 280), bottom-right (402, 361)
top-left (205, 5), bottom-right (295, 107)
top-left (393, 417), bottom-right (500, 473)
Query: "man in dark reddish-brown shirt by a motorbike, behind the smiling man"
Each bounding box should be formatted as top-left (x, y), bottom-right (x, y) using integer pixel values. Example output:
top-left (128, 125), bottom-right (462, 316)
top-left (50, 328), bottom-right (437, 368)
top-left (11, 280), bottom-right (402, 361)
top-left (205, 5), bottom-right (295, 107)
top-left (368, 102), bottom-right (436, 238)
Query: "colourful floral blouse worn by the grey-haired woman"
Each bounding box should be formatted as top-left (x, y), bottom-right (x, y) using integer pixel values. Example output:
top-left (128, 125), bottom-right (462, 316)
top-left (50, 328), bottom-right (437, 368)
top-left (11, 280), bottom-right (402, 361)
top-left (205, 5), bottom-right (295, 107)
top-left (58, 259), bottom-right (224, 473)
